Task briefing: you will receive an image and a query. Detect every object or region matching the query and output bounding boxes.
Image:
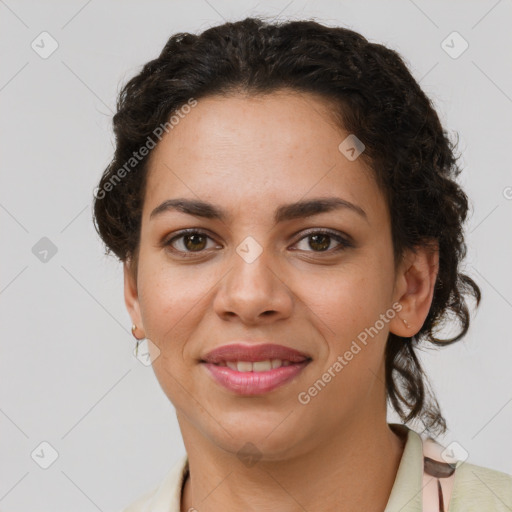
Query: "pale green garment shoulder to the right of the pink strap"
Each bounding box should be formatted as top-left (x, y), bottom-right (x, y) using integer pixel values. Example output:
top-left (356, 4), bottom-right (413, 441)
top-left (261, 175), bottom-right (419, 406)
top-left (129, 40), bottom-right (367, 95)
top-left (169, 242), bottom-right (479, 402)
top-left (450, 462), bottom-right (512, 512)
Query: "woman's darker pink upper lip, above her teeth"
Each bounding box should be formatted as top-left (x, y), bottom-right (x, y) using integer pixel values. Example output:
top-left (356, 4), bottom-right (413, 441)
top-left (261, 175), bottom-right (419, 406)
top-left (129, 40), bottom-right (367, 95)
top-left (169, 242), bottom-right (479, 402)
top-left (201, 343), bottom-right (311, 364)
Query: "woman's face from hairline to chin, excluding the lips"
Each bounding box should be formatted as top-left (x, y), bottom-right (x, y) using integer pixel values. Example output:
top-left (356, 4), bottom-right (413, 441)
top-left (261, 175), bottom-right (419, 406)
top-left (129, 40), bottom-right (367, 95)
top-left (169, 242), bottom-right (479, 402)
top-left (125, 91), bottom-right (428, 459)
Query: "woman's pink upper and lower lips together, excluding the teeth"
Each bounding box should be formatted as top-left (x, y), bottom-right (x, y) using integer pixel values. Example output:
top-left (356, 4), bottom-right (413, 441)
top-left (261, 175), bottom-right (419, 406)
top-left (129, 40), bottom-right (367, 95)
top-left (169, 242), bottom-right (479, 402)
top-left (201, 343), bottom-right (311, 395)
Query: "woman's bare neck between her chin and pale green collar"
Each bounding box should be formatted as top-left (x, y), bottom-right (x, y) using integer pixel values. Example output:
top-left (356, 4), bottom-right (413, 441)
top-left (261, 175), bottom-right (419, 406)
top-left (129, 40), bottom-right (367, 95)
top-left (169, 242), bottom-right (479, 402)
top-left (178, 415), bottom-right (405, 512)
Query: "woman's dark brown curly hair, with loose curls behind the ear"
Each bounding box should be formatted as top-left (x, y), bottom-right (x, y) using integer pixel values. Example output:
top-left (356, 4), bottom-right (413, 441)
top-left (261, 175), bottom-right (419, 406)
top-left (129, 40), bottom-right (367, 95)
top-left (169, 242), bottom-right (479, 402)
top-left (94, 18), bottom-right (481, 434)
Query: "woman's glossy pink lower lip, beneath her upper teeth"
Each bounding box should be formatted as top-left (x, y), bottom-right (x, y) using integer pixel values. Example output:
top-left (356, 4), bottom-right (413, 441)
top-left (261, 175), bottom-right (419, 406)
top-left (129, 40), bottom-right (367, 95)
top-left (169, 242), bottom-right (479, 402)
top-left (203, 361), bottom-right (310, 395)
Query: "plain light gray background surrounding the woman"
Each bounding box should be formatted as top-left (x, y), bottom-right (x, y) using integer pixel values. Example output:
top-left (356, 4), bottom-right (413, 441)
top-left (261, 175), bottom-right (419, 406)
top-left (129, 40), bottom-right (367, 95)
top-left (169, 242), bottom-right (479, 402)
top-left (0, 0), bottom-right (512, 512)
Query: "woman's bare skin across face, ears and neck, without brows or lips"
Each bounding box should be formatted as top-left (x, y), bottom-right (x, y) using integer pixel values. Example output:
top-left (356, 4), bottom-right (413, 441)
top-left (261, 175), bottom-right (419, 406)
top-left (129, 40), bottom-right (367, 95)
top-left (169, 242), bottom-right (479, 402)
top-left (124, 90), bottom-right (438, 512)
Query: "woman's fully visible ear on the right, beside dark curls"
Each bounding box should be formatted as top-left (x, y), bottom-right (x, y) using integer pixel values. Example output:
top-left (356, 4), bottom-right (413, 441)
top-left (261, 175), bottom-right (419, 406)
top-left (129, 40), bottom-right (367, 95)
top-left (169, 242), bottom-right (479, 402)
top-left (389, 241), bottom-right (439, 338)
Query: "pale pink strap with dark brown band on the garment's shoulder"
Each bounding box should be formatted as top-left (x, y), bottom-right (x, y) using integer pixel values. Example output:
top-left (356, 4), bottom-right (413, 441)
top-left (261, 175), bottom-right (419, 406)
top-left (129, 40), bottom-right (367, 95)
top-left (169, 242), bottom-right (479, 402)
top-left (423, 438), bottom-right (456, 512)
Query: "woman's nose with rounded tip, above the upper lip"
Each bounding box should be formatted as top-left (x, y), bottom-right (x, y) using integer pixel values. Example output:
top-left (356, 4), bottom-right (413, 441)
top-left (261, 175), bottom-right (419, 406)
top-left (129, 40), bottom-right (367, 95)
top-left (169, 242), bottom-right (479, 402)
top-left (213, 247), bottom-right (294, 325)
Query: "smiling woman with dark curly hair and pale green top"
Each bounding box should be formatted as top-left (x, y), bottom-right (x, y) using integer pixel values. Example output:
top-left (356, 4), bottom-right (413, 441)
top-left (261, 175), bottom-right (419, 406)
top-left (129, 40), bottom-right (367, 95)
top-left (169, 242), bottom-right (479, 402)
top-left (95, 18), bottom-right (512, 512)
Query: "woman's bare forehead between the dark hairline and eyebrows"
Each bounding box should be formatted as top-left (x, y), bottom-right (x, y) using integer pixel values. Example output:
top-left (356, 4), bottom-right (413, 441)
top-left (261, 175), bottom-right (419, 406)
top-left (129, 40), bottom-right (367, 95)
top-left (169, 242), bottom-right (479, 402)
top-left (143, 91), bottom-right (382, 222)
